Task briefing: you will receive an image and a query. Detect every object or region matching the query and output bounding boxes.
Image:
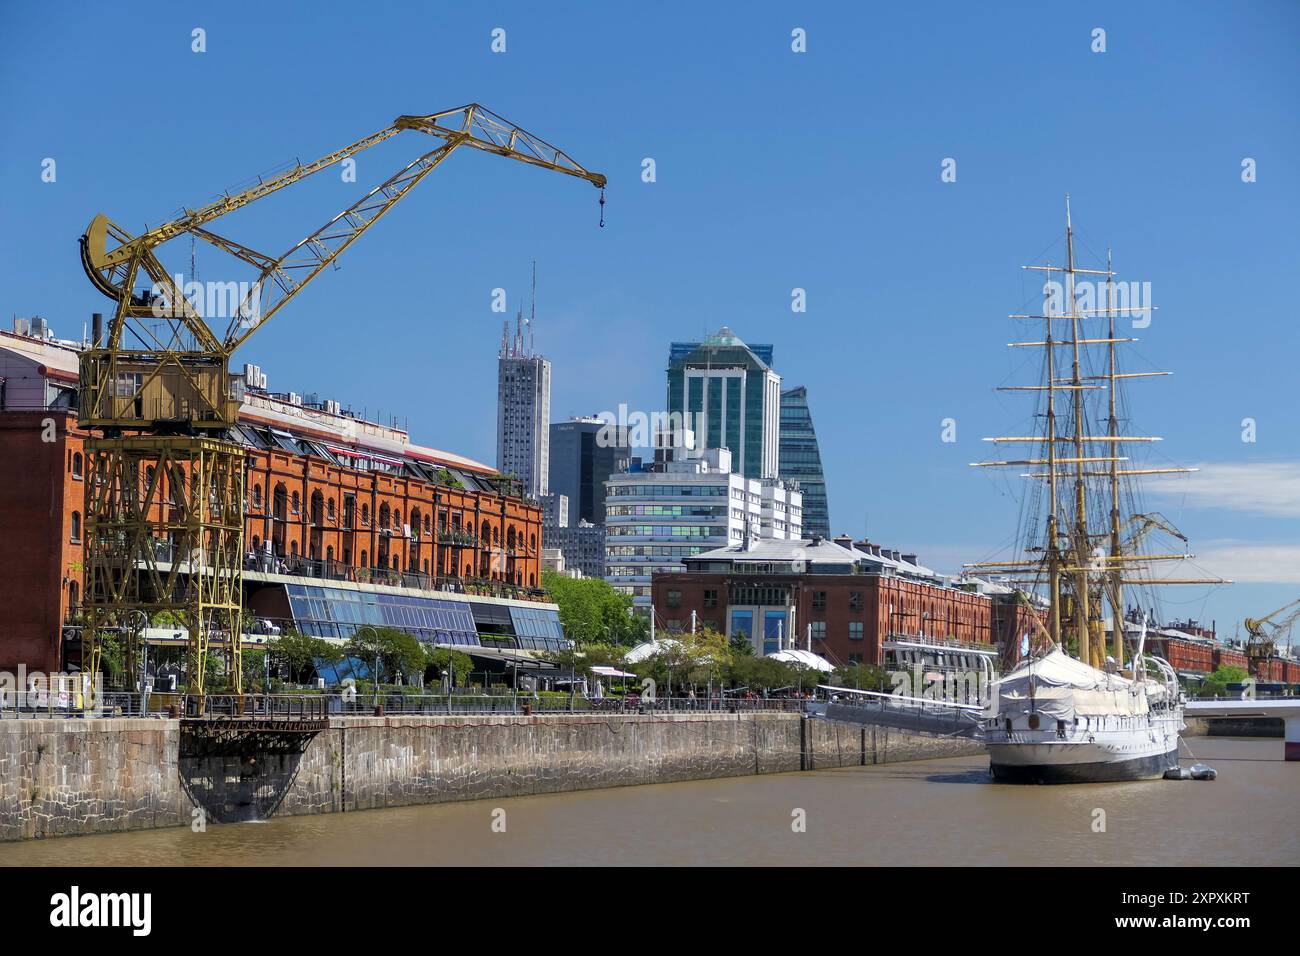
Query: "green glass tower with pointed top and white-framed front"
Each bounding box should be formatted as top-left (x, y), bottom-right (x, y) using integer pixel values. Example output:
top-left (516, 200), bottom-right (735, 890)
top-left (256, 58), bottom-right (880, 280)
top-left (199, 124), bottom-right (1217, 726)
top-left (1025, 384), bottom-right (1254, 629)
top-left (668, 326), bottom-right (781, 479)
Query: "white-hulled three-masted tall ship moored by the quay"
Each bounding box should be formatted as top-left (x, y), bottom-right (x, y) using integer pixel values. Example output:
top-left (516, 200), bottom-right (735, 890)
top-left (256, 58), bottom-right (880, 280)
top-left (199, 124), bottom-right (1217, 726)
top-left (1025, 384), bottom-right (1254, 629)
top-left (966, 196), bottom-right (1227, 783)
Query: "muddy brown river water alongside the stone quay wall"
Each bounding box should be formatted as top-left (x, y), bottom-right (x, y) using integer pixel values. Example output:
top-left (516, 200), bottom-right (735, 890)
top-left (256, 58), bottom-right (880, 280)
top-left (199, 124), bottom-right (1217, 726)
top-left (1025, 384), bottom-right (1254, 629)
top-left (0, 737), bottom-right (1300, 866)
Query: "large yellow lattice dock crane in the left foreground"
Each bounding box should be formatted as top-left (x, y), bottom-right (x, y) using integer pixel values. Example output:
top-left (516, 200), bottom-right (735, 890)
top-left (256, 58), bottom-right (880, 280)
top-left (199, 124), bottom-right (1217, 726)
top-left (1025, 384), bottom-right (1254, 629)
top-left (79, 103), bottom-right (606, 713)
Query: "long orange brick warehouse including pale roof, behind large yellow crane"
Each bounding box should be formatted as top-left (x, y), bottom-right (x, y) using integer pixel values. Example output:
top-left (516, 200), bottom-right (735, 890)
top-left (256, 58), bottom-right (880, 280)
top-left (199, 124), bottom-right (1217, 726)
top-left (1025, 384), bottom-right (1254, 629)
top-left (0, 320), bottom-right (546, 671)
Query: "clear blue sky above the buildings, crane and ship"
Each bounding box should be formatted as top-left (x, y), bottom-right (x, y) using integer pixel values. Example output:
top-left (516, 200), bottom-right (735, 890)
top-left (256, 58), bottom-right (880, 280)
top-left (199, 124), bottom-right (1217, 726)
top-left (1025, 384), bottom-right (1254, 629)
top-left (0, 0), bottom-right (1300, 632)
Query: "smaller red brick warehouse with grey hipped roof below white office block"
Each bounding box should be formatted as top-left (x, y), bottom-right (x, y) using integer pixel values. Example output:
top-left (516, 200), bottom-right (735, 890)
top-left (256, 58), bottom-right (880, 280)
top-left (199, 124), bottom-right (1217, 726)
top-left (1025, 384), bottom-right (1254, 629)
top-left (651, 537), bottom-right (1000, 665)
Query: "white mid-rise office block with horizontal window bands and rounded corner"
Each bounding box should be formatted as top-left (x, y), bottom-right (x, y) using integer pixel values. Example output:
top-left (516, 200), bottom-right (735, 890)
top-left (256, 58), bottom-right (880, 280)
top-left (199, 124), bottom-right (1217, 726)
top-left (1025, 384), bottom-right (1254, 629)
top-left (605, 429), bottom-right (802, 609)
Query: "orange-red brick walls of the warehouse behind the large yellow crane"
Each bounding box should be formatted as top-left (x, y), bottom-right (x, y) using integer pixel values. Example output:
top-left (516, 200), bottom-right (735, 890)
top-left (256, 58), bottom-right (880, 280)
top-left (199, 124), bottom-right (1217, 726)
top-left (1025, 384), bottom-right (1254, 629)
top-left (0, 410), bottom-right (542, 671)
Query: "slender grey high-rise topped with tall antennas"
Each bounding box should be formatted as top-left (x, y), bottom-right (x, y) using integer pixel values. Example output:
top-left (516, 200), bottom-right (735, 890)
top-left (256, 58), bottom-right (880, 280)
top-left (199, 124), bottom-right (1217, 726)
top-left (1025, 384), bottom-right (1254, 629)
top-left (497, 312), bottom-right (551, 498)
